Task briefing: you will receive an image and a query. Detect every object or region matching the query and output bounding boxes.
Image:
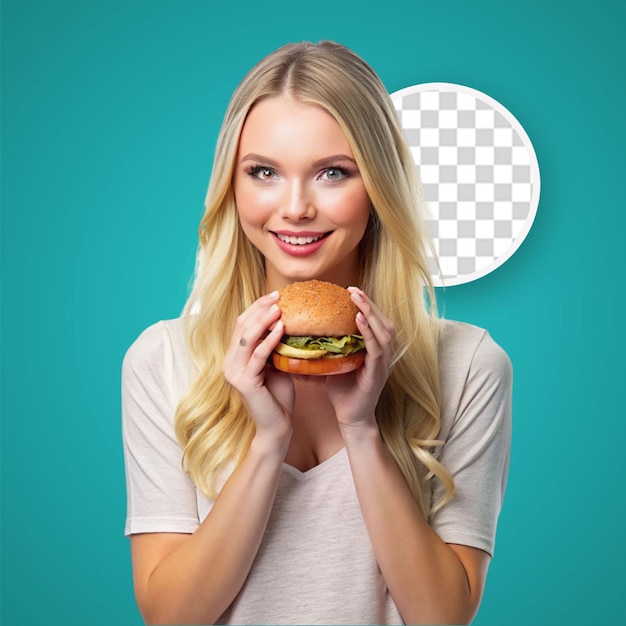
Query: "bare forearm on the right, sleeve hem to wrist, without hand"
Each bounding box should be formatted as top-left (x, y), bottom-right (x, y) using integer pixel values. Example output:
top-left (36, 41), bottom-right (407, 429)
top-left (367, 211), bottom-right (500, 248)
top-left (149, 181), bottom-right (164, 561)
top-left (342, 423), bottom-right (489, 624)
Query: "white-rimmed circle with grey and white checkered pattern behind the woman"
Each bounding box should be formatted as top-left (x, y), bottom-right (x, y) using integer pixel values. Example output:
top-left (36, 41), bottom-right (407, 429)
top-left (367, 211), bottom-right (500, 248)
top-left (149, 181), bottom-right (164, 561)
top-left (391, 83), bottom-right (540, 287)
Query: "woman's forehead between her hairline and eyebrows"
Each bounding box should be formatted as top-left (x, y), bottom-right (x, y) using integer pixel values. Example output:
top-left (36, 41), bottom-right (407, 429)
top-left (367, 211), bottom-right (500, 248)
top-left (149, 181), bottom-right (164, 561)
top-left (239, 96), bottom-right (352, 155)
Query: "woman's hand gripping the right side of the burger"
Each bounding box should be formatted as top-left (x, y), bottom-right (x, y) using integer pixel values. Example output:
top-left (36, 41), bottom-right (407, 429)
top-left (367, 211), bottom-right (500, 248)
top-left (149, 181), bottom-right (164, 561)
top-left (326, 287), bottom-right (395, 430)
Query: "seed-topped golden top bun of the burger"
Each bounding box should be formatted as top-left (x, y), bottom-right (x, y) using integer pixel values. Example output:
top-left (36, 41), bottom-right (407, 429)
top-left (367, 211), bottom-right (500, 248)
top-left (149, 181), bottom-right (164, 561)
top-left (278, 280), bottom-right (359, 337)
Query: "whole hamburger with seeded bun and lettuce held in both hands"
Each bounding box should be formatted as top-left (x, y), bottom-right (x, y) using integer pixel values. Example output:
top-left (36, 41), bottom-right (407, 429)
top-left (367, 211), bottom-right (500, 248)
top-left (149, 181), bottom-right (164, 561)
top-left (272, 280), bottom-right (365, 376)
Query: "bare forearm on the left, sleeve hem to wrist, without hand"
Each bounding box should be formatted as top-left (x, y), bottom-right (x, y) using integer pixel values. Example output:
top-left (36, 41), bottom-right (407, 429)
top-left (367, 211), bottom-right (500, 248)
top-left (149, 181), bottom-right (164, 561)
top-left (131, 428), bottom-right (288, 624)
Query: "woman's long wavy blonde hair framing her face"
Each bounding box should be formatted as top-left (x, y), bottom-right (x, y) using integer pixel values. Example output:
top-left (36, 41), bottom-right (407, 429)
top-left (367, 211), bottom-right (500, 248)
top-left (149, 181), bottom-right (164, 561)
top-left (175, 41), bottom-right (454, 516)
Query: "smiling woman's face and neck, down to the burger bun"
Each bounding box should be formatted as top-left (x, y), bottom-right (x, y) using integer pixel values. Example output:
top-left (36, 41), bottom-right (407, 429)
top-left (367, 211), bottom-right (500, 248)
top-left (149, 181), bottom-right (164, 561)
top-left (234, 96), bottom-right (370, 291)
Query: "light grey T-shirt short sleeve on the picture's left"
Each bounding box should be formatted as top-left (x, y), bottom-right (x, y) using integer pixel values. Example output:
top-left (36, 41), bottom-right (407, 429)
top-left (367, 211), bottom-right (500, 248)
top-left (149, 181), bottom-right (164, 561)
top-left (122, 322), bottom-right (199, 535)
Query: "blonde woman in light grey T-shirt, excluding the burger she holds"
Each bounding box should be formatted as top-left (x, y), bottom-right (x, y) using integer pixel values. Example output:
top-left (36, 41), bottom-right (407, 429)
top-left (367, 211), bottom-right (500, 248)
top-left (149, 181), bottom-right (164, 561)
top-left (123, 42), bottom-right (511, 624)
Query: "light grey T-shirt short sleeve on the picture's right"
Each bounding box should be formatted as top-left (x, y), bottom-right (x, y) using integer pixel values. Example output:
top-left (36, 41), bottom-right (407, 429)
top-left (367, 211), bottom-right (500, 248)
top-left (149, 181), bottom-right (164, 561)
top-left (431, 327), bottom-right (512, 555)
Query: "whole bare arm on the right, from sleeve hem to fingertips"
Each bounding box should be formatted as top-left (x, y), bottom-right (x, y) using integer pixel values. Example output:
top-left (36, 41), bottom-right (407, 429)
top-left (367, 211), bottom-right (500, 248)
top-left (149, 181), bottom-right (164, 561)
top-left (327, 289), bottom-right (502, 623)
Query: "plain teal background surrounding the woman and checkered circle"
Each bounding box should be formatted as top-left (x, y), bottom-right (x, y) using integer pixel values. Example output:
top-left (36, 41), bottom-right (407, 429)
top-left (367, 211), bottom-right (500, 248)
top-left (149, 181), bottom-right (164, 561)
top-left (2, 0), bottom-right (626, 626)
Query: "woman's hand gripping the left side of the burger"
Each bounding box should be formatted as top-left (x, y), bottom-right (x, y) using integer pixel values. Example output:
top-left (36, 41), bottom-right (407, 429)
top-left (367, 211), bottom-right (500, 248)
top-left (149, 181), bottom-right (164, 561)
top-left (222, 292), bottom-right (295, 440)
